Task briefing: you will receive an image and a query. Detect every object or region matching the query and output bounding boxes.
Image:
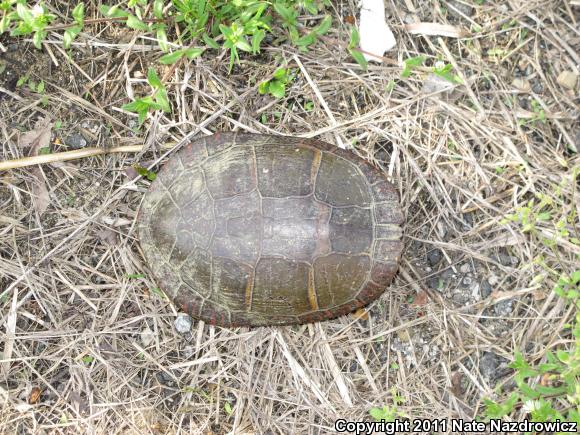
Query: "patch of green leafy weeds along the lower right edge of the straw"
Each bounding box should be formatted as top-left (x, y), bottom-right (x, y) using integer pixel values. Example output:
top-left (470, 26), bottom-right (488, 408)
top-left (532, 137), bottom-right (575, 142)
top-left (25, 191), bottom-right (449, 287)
top-left (484, 168), bottom-right (580, 425)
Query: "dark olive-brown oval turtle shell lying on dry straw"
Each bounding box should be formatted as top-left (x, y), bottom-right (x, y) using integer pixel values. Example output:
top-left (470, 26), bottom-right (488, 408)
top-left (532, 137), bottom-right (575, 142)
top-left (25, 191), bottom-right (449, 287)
top-left (138, 132), bottom-right (404, 327)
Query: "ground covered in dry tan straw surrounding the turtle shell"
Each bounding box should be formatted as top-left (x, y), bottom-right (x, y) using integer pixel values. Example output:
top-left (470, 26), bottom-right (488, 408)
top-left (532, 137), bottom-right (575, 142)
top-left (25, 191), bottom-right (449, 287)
top-left (0, 0), bottom-right (580, 434)
